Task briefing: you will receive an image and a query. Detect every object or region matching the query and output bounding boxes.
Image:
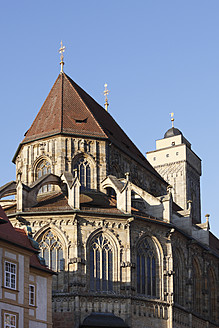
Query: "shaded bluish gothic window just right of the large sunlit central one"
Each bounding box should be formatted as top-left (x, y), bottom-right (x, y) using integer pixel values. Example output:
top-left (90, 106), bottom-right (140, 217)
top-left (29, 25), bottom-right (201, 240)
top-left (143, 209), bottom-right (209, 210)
top-left (137, 238), bottom-right (157, 297)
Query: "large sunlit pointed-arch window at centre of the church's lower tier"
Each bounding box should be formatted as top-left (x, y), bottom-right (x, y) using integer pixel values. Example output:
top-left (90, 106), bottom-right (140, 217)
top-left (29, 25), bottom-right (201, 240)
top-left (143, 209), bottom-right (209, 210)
top-left (90, 233), bottom-right (113, 291)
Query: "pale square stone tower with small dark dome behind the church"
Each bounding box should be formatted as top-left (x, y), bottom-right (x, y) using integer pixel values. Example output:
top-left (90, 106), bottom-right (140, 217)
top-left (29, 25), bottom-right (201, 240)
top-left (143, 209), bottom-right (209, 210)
top-left (147, 127), bottom-right (201, 223)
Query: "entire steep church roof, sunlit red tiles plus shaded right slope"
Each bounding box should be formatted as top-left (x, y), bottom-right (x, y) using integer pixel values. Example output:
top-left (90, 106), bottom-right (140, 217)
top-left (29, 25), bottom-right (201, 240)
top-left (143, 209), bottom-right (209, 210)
top-left (18, 73), bottom-right (164, 181)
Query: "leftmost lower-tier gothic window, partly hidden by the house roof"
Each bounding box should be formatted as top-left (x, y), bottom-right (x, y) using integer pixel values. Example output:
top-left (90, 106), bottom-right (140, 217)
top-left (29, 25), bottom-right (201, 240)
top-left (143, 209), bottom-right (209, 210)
top-left (39, 230), bottom-right (64, 271)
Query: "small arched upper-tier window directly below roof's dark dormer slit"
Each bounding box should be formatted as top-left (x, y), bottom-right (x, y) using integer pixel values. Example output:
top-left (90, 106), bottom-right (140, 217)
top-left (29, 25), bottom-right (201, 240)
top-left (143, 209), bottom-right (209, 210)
top-left (74, 158), bottom-right (91, 189)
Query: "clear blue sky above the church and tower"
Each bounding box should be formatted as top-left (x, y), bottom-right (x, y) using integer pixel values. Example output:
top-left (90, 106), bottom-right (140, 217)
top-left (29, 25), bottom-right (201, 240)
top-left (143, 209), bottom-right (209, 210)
top-left (0, 0), bottom-right (219, 236)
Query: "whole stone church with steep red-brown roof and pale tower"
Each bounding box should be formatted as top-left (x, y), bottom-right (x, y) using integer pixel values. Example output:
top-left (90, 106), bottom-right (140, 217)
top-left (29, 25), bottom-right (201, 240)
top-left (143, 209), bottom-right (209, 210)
top-left (0, 68), bottom-right (219, 328)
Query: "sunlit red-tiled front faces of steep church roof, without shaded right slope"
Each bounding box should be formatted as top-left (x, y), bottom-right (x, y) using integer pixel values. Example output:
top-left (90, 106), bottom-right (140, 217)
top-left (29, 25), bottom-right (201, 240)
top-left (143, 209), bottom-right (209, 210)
top-left (23, 73), bottom-right (107, 142)
